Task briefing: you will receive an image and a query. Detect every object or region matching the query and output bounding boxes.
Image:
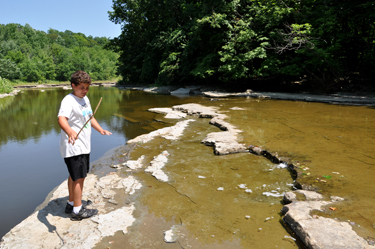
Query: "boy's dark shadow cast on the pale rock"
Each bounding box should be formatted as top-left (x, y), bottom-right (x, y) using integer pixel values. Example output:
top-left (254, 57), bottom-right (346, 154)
top-left (36, 197), bottom-right (90, 244)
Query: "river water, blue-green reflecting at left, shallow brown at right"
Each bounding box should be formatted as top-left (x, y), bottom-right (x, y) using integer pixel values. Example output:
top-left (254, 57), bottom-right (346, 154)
top-left (0, 87), bottom-right (375, 248)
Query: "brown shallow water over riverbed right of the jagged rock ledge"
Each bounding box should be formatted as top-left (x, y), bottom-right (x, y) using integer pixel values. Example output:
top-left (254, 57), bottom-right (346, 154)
top-left (210, 98), bottom-right (375, 238)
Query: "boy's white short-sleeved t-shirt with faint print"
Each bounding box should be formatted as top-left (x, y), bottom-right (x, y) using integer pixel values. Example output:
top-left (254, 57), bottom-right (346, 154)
top-left (57, 93), bottom-right (92, 158)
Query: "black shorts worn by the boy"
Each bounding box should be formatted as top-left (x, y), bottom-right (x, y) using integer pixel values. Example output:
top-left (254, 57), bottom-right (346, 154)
top-left (64, 154), bottom-right (90, 181)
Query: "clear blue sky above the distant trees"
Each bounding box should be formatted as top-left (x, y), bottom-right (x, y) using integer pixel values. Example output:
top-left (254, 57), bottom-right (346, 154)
top-left (0, 0), bottom-right (121, 38)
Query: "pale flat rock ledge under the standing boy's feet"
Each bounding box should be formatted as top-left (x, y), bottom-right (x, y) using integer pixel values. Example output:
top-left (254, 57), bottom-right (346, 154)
top-left (0, 172), bottom-right (141, 249)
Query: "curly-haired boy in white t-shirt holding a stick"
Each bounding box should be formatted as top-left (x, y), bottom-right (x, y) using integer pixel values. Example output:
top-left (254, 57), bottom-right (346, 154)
top-left (58, 71), bottom-right (112, 220)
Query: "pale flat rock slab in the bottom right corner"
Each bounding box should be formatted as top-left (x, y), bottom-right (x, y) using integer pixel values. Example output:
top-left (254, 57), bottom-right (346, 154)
top-left (281, 190), bottom-right (375, 249)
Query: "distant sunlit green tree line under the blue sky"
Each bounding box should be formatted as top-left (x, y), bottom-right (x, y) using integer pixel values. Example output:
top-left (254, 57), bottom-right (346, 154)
top-left (0, 23), bottom-right (118, 82)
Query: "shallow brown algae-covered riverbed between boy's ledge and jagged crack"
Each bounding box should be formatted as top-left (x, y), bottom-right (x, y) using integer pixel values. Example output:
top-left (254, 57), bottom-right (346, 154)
top-left (97, 114), bottom-right (297, 248)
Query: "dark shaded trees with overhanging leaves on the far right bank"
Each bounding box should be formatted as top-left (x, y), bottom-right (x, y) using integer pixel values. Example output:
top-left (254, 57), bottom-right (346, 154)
top-left (110, 0), bottom-right (375, 90)
